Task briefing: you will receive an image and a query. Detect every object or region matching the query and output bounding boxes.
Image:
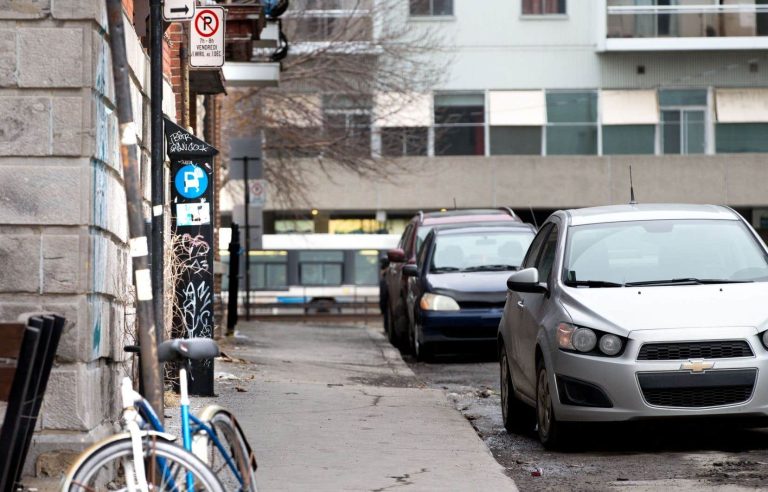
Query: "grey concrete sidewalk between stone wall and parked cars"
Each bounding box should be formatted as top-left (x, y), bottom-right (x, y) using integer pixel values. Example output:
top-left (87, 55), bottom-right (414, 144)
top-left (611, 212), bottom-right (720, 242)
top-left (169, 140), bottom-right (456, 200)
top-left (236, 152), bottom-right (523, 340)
top-left (212, 323), bottom-right (516, 491)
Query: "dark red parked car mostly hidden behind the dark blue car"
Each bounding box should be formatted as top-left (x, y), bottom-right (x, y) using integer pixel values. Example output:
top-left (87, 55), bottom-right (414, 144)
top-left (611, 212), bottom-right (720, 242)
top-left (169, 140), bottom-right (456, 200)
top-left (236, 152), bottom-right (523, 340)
top-left (379, 208), bottom-right (522, 349)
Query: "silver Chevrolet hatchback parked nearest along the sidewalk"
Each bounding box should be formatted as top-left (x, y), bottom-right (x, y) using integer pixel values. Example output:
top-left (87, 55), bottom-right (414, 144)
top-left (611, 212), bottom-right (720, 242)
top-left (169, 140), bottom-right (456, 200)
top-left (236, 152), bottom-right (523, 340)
top-left (499, 205), bottom-right (768, 447)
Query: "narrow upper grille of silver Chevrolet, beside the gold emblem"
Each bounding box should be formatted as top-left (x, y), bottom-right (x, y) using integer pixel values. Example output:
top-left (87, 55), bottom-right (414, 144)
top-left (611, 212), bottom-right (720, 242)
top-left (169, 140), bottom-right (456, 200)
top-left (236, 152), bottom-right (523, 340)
top-left (637, 340), bottom-right (754, 360)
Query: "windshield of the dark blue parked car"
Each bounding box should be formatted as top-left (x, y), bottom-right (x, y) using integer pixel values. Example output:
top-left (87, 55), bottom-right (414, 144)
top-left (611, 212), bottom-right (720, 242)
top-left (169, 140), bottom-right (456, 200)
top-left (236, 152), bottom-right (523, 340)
top-left (430, 231), bottom-right (533, 273)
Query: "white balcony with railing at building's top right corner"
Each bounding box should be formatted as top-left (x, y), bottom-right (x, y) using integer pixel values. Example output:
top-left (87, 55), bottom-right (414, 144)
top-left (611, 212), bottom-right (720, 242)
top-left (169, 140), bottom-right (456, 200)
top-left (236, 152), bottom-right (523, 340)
top-left (602, 0), bottom-right (768, 51)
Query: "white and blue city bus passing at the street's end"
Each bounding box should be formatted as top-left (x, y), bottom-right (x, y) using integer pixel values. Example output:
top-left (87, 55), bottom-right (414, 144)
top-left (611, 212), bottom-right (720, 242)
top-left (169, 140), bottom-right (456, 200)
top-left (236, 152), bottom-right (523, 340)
top-left (220, 229), bottom-right (400, 314)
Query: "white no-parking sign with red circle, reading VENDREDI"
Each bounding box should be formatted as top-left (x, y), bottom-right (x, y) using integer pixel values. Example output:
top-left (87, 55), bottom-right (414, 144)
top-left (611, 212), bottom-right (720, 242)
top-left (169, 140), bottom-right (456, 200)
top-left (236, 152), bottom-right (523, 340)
top-left (189, 7), bottom-right (225, 68)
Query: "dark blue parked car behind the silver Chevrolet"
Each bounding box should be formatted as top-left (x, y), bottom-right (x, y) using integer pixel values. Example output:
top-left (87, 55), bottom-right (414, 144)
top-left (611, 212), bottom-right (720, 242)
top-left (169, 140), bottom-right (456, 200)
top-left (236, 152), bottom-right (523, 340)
top-left (403, 223), bottom-right (535, 359)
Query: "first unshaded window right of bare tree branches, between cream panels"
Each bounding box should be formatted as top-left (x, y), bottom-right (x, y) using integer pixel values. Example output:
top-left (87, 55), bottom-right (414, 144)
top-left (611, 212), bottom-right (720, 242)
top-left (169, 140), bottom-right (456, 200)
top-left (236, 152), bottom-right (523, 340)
top-left (435, 93), bottom-right (485, 155)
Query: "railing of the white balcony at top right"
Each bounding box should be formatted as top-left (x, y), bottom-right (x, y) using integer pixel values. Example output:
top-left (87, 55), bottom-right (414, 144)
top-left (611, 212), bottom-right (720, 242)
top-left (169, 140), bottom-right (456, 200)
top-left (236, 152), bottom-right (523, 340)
top-left (606, 0), bottom-right (768, 38)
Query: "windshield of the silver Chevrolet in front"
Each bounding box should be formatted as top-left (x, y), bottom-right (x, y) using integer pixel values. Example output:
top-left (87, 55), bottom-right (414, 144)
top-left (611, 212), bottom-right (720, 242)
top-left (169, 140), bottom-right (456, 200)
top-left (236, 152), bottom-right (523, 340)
top-left (563, 220), bottom-right (768, 287)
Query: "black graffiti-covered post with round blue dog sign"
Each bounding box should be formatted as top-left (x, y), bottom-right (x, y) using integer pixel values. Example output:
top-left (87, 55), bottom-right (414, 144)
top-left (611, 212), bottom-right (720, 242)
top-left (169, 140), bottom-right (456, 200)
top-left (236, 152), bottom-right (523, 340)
top-left (165, 118), bottom-right (219, 396)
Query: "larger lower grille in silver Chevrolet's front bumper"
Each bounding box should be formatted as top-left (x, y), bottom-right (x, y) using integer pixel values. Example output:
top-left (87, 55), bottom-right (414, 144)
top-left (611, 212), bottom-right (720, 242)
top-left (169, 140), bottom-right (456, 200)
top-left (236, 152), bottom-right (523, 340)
top-left (637, 369), bottom-right (757, 408)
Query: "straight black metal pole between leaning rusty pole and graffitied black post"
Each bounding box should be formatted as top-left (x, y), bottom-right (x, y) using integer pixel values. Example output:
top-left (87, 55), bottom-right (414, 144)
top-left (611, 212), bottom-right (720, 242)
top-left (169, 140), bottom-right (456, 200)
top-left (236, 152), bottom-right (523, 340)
top-left (149, 0), bottom-right (165, 343)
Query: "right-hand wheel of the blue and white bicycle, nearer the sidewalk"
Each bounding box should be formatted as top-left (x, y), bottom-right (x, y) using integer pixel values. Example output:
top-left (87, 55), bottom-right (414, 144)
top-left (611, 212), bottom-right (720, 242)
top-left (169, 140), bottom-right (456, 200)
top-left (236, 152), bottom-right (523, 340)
top-left (192, 405), bottom-right (256, 492)
